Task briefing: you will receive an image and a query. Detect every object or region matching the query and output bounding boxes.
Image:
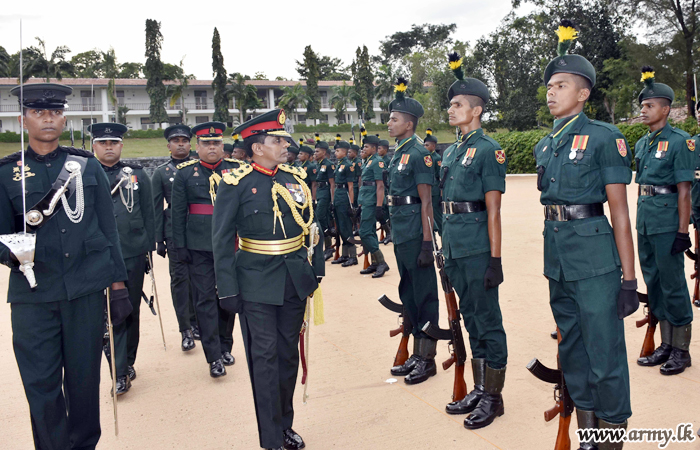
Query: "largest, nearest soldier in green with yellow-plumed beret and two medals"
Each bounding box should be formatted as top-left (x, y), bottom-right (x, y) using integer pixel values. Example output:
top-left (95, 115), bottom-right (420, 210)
top-left (534, 20), bottom-right (639, 450)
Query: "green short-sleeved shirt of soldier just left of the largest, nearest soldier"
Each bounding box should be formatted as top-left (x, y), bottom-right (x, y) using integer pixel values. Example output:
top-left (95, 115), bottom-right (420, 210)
top-left (442, 128), bottom-right (508, 259)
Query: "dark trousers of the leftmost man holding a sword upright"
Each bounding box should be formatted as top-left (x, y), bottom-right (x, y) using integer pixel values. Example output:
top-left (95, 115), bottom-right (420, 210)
top-left (11, 291), bottom-right (105, 449)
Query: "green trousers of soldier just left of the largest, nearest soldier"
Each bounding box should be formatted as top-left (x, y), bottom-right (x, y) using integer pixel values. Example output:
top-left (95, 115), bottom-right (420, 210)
top-left (445, 252), bottom-right (508, 369)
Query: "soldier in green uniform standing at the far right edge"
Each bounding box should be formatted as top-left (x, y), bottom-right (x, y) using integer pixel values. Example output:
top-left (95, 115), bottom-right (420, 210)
top-left (634, 66), bottom-right (697, 375)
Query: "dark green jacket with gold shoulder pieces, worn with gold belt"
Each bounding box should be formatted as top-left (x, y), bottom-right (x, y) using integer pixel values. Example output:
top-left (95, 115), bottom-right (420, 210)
top-left (213, 164), bottom-right (325, 306)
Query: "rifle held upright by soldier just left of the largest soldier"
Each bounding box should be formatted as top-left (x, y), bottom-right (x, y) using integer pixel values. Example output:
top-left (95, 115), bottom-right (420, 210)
top-left (423, 218), bottom-right (467, 402)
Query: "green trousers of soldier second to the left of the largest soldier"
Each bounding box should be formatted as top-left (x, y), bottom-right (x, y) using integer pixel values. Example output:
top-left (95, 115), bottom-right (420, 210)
top-left (394, 236), bottom-right (439, 339)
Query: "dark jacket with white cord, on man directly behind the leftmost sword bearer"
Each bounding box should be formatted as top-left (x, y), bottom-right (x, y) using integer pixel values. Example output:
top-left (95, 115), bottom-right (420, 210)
top-left (102, 161), bottom-right (156, 259)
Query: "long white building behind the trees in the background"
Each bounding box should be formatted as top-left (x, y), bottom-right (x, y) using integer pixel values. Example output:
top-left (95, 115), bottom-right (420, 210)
top-left (0, 78), bottom-right (381, 133)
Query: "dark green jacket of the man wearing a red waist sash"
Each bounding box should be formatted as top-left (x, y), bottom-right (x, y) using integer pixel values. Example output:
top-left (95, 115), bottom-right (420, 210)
top-left (172, 158), bottom-right (240, 252)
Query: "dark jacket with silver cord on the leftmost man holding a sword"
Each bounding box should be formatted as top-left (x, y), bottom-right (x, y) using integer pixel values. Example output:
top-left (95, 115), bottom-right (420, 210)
top-left (0, 147), bottom-right (126, 303)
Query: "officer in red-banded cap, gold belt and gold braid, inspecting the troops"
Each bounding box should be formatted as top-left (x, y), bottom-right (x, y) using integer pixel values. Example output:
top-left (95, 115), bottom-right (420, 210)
top-left (213, 109), bottom-right (324, 450)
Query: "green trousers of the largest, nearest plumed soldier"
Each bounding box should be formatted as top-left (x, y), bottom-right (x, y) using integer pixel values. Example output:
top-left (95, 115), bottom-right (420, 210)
top-left (549, 269), bottom-right (632, 423)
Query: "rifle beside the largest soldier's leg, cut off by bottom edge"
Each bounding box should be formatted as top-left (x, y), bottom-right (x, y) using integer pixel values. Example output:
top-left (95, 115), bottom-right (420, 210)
top-left (527, 327), bottom-right (574, 450)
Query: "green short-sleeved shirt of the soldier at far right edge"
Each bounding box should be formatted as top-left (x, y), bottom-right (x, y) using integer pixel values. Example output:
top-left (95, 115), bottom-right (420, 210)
top-left (634, 124), bottom-right (697, 234)
